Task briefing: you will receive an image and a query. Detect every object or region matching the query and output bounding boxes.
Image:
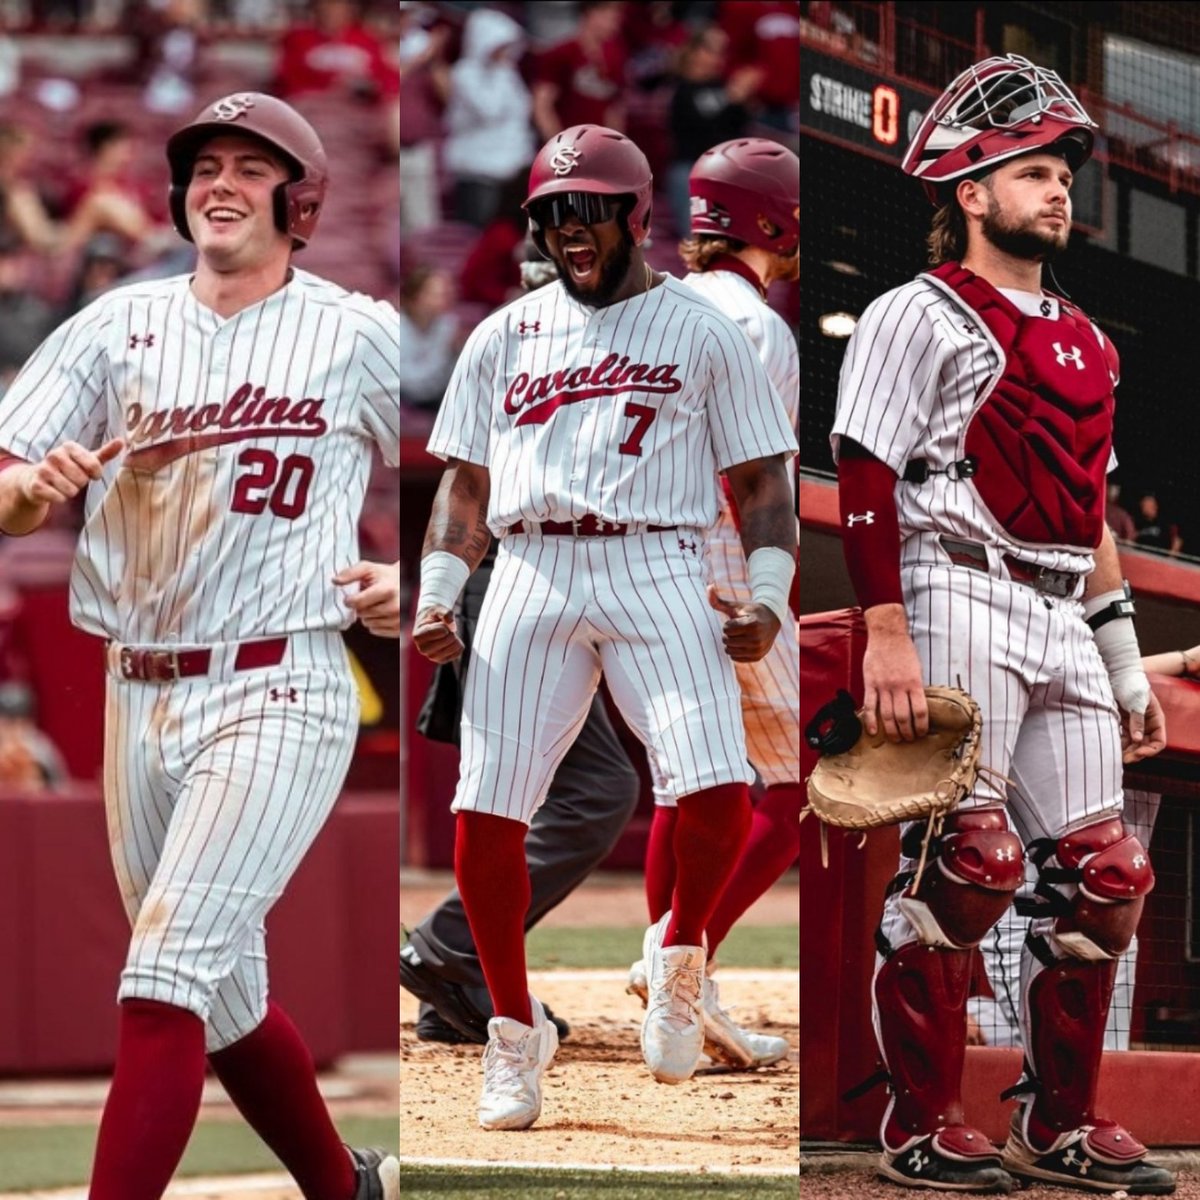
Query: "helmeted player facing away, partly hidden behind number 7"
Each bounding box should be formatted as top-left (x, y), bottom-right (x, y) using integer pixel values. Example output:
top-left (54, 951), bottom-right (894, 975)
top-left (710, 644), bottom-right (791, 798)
top-left (629, 138), bottom-right (803, 1068)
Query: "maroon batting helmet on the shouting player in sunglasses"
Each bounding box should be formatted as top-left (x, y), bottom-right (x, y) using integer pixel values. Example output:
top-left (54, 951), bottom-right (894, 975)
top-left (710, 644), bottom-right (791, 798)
top-left (521, 125), bottom-right (654, 258)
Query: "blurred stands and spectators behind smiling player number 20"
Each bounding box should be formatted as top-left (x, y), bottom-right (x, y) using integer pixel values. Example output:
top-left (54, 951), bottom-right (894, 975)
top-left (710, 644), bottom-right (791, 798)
top-left (0, 0), bottom-right (401, 790)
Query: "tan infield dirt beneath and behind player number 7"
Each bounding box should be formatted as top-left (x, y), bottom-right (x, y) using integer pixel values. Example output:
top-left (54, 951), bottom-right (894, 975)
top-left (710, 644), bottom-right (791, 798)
top-left (400, 880), bottom-right (799, 1176)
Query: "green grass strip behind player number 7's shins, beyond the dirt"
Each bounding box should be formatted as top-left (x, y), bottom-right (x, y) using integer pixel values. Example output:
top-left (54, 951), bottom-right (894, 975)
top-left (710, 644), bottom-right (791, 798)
top-left (526, 925), bottom-right (800, 970)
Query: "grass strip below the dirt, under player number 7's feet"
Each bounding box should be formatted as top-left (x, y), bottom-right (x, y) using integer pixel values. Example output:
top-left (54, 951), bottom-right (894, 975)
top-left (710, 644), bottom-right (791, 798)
top-left (400, 1166), bottom-right (797, 1200)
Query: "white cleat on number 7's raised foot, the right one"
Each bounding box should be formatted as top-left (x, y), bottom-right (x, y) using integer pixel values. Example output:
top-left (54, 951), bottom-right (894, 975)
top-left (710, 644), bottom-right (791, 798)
top-left (642, 912), bottom-right (704, 1084)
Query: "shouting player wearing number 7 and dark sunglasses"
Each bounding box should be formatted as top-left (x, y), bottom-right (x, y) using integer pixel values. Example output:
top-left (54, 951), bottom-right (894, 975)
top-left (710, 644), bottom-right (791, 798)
top-left (413, 125), bottom-right (796, 1129)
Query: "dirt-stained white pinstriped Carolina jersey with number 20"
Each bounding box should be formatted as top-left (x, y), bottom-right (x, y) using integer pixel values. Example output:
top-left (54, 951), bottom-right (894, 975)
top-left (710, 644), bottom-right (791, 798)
top-left (0, 270), bottom-right (400, 646)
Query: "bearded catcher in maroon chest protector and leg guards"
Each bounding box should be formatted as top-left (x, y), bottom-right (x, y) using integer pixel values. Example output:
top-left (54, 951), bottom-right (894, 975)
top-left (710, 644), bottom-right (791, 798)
top-left (833, 55), bottom-right (1175, 1195)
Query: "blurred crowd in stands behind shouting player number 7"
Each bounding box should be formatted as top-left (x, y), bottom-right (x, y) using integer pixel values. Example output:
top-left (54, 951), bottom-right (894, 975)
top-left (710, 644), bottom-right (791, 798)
top-left (400, 0), bottom-right (800, 420)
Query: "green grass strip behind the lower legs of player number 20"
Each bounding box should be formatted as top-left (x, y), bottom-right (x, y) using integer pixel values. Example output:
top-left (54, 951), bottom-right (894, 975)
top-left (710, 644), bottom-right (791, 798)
top-left (0, 1117), bottom-right (397, 1192)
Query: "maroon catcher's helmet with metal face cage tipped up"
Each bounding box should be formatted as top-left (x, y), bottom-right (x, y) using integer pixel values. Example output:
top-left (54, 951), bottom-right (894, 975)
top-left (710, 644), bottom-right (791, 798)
top-left (900, 54), bottom-right (1097, 204)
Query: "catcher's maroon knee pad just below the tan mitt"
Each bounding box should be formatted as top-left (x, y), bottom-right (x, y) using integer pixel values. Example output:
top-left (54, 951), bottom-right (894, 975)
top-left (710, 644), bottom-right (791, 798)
top-left (899, 809), bottom-right (1025, 949)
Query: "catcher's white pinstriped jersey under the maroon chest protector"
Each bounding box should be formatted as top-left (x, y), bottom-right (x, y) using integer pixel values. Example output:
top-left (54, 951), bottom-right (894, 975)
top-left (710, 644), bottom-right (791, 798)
top-left (830, 278), bottom-right (1116, 574)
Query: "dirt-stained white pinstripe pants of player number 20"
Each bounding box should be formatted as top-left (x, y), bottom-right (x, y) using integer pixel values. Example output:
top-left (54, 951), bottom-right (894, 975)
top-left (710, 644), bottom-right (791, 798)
top-left (104, 632), bottom-right (359, 1050)
